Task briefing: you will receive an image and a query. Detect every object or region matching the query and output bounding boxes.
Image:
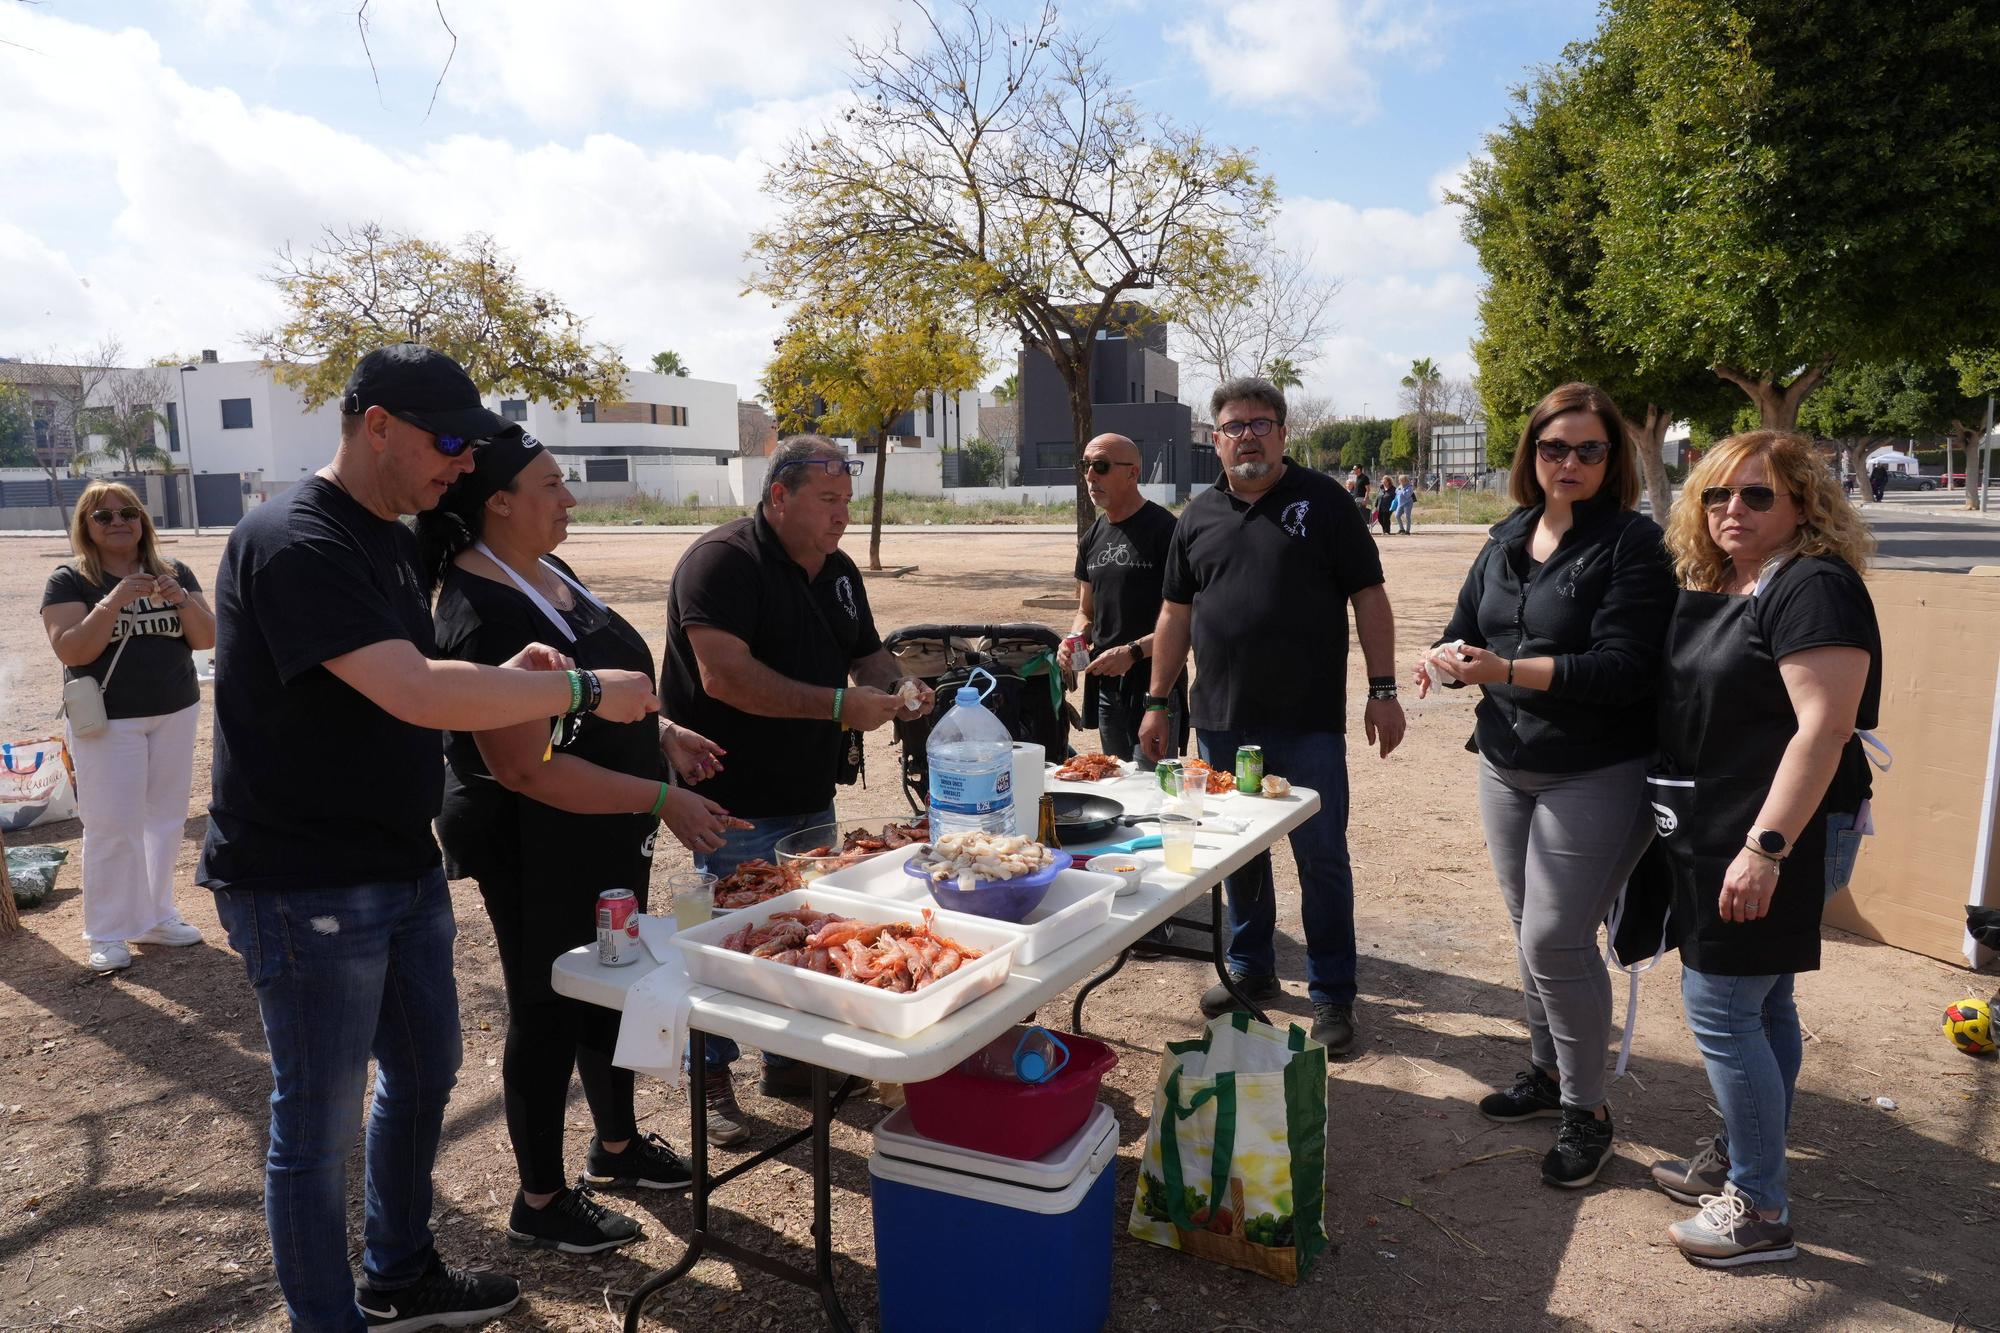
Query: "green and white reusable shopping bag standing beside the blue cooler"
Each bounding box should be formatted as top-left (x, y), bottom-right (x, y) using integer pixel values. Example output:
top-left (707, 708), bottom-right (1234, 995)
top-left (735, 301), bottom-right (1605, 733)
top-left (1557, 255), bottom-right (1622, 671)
top-left (1126, 1011), bottom-right (1326, 1283)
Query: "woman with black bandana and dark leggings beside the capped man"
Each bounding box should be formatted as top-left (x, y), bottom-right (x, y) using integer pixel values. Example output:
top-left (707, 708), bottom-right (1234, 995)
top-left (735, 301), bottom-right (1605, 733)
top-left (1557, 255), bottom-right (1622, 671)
top-left (418, 436), bottom-right (728, 1255)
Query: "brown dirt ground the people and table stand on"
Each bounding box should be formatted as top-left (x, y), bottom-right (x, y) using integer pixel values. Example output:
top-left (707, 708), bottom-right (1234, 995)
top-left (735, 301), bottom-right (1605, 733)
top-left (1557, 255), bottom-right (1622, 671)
top-left (0, 532), bottom-right (2000, 1333)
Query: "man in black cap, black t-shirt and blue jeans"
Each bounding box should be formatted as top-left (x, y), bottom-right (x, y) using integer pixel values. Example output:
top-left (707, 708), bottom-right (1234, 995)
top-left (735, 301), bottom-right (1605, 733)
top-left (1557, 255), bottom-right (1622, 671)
top-left (196, 344), bottom-right (658, 1333)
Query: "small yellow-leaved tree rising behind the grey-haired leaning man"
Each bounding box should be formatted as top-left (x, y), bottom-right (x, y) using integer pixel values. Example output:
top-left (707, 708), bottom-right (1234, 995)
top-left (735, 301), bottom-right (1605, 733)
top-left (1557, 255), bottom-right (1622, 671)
top-left (764, 296), bottom-right (984, 568)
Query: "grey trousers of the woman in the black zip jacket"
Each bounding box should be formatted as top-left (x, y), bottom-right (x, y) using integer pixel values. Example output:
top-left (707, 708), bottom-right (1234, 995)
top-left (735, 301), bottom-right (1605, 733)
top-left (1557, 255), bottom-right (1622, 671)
top-left (1480, 759), bottom-right (1652, 1111)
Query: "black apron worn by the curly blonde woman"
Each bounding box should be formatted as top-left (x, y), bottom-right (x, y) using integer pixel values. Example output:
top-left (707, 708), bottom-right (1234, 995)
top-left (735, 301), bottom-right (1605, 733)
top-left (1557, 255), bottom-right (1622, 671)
top-left (1646, 562), bottom-right (1854, 977)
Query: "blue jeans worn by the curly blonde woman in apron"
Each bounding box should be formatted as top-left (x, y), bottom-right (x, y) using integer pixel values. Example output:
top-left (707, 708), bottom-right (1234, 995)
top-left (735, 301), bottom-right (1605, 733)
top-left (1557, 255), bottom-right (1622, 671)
top-left (1680, 967), bottom-right (1804, 1213)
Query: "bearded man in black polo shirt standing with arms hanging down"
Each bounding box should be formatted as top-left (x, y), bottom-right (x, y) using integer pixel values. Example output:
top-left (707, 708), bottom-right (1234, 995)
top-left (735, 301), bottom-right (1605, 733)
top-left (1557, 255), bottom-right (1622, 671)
top-left (1140, 378), bottom-right (1404, 1055)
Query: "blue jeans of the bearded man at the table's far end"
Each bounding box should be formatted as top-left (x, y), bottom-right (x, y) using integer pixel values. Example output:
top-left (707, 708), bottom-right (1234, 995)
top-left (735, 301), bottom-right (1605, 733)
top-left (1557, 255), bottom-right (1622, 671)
top-left (1200, 729), bottom-right (1354, 1005)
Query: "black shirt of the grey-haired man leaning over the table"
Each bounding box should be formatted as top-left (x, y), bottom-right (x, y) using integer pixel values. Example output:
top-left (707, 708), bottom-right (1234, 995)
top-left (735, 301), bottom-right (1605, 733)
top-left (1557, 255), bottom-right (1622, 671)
top-left (660, 508), bottom-right (882, 819)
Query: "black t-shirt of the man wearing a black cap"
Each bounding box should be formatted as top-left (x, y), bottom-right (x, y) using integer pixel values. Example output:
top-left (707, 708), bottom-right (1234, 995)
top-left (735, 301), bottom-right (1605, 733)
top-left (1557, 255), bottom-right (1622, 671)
top-left (196, 476), bottom-right (444, 889)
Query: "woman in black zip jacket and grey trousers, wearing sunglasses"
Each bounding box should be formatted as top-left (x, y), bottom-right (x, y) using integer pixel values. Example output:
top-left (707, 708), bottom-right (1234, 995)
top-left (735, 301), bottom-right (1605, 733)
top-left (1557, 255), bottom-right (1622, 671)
top-left (1416, 384), bottom-right (1674, 1189)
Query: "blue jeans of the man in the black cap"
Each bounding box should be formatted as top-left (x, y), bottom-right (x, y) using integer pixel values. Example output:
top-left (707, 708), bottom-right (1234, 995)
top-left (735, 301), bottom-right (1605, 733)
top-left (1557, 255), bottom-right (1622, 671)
top-left (216, 871), bottom-right (462, 1333)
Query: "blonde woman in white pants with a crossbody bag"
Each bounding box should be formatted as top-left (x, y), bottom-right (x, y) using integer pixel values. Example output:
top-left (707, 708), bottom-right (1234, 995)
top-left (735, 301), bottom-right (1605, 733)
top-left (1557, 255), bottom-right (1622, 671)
top-left (42, 482), bottom-right (216, 973)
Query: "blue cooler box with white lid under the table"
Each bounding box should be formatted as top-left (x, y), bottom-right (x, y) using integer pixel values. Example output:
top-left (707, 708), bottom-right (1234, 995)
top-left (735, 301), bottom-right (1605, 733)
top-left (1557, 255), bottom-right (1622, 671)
top-left (868, 1103), bottom-right (1118, 1333)
